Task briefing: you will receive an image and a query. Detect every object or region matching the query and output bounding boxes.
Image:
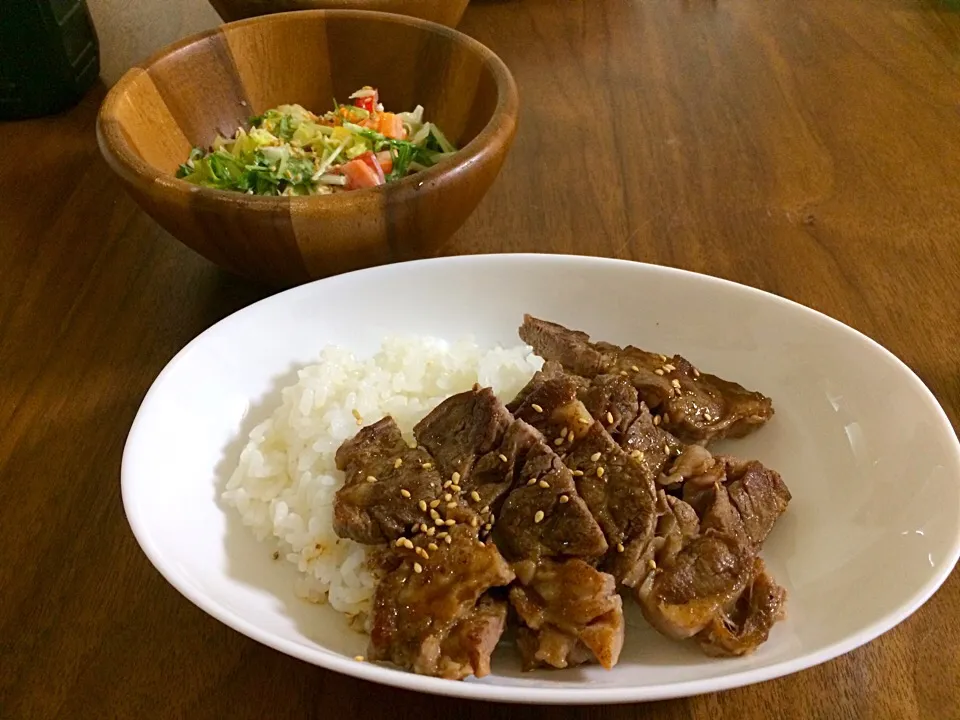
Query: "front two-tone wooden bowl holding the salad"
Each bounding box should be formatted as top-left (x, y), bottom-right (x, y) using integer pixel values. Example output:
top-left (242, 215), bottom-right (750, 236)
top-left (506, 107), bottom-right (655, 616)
top-left (97, 10), bottom-right (519, 285)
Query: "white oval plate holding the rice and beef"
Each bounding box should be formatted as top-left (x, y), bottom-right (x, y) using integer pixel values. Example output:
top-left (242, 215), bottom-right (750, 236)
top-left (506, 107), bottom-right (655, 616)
top-left (122, 255), bottom-right (960, 704)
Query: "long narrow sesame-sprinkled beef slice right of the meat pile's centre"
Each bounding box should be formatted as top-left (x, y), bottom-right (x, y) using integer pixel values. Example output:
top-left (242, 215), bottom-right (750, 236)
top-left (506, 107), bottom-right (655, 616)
top-left (564, 423), bottom-right (657, 582)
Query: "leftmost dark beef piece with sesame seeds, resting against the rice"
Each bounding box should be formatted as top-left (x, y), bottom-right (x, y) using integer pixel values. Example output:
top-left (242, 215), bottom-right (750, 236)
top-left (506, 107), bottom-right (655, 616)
top-left (333, 416), bottom-right (452, 544)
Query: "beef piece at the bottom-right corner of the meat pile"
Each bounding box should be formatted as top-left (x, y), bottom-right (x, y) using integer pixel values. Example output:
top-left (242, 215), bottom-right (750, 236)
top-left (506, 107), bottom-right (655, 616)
top-left (696, 558), bottom-right (787, 657)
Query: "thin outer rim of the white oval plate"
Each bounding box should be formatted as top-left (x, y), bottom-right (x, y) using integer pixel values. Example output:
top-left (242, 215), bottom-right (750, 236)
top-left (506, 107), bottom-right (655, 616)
top-left (120, 253), bottom-right (960, 705)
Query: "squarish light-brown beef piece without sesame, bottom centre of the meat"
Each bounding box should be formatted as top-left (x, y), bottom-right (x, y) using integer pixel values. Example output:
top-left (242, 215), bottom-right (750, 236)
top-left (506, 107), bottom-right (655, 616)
top-left (510, 558), bottom-right (625, 670)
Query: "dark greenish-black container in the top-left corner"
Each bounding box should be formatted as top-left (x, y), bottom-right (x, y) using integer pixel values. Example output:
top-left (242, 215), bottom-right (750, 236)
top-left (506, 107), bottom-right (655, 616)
top-left (0, 0), bottom-right (100, 120)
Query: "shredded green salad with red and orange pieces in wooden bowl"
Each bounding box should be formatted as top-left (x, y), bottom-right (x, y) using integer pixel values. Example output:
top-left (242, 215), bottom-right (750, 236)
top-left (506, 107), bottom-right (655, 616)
top-left (177, 87), bottom-right (457, 195)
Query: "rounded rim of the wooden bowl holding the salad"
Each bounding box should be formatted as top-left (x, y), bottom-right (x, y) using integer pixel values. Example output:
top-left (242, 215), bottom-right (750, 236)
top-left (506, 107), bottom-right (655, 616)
top-left (97, 10), bottom-right (520, 213)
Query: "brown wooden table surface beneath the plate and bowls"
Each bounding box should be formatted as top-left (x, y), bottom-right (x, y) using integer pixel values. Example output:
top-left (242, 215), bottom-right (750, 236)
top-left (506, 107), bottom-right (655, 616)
top-left (0, 0), bottom-right (960, 720)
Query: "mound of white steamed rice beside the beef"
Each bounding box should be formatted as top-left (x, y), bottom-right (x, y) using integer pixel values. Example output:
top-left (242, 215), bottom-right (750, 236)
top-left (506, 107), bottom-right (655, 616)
top-left (223, 337), bottom-right (542, 617)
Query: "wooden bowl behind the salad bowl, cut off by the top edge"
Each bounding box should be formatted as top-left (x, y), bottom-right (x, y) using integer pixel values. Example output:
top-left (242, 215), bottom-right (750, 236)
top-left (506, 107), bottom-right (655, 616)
top-left (210, 0), bottom-right (470, 27)
